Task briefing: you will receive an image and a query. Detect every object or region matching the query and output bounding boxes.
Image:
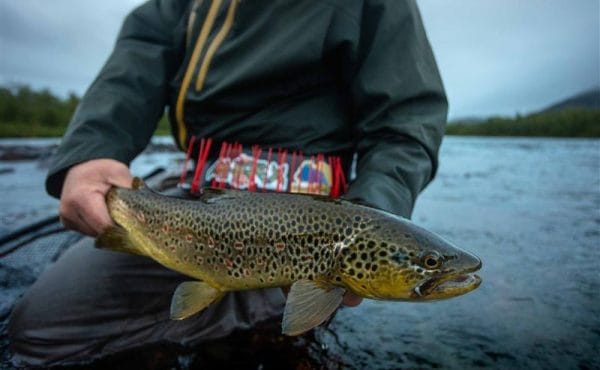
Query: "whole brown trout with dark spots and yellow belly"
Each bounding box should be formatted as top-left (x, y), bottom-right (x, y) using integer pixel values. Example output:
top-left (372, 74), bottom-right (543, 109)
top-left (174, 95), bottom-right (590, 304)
top-left (96, 178), bottom-right (481, 335)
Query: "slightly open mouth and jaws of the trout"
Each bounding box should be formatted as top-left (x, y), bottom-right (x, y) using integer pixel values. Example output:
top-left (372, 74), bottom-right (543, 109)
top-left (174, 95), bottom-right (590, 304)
top-left (411, 265), bottom-right (481, 300)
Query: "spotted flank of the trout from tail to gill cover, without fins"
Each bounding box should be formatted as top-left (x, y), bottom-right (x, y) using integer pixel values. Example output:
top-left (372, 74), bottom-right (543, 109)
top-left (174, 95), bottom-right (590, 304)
top-left (107, 182), bottom-right (368, 290)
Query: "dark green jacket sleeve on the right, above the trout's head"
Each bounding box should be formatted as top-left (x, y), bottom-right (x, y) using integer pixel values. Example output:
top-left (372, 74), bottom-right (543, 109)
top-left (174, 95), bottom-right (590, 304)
top-left (344, 0), bottom-right (447, 217)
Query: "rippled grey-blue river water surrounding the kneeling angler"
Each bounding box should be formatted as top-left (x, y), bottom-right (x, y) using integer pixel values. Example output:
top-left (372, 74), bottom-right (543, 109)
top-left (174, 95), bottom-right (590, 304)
top-left (0, 137), bottom-right (600, 369)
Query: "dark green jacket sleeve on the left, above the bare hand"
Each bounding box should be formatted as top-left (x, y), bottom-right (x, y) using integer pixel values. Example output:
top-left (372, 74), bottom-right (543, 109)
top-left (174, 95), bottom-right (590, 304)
top-left (46, 0), bottom-right (188, 197)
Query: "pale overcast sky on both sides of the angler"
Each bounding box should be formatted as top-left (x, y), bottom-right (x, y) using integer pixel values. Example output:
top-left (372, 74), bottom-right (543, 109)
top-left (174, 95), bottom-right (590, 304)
top-left (0, 0), bottom-right (600, 118)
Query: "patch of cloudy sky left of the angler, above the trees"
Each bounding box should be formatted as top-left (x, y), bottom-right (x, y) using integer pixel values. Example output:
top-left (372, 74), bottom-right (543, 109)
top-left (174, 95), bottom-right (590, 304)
top-left (0, 0), bottom-right (140, 94)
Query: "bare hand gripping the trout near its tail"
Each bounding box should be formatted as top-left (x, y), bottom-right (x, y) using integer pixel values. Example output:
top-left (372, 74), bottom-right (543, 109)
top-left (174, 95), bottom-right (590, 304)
top-left (59, 159), bottom-right (133, 236)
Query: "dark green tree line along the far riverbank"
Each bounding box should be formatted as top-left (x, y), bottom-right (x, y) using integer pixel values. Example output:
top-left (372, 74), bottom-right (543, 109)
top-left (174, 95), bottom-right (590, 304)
top-left (0, 85), bottom-right (600, 137)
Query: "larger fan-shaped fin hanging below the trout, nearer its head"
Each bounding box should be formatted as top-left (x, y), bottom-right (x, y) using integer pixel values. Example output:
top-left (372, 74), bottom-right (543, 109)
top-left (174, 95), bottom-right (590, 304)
top-left (282, 280), bottom-right (345, 335)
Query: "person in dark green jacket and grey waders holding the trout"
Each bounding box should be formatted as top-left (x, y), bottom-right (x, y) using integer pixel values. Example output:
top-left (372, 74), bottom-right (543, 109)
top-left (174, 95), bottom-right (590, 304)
top-left (9, 0), bottom-right (447, 366)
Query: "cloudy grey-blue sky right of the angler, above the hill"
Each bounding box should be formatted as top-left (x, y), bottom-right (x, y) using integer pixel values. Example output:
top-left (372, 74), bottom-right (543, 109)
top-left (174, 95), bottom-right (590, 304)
top-left (418, 0), bottom-right (600, 117)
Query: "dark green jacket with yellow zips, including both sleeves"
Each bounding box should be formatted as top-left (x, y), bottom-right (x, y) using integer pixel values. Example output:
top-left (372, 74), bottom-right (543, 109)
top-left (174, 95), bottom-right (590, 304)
top-left (46, 0), bottom-right (447, 217)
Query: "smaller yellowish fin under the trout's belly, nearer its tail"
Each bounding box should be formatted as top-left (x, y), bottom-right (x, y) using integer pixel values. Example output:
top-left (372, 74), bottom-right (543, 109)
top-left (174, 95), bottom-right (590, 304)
top-left (171, 281), bottom-right (225, 320)
